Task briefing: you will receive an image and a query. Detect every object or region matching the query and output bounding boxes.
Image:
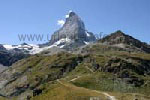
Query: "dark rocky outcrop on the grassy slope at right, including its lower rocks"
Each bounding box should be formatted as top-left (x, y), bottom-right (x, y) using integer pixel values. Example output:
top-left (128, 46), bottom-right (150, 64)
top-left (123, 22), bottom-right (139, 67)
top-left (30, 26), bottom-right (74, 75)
top-left (102, 58), bottom-right (150, 87)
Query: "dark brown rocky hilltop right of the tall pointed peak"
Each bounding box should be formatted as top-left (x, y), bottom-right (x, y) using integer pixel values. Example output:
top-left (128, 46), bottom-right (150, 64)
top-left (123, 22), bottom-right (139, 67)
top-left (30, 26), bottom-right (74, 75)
top-left (100, 30), bottom-right (150, 53)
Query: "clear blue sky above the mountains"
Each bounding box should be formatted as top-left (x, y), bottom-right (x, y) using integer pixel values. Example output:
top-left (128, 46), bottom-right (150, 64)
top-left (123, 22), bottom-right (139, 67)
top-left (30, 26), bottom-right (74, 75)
top-left (0, 0), bottom-right (150, 44)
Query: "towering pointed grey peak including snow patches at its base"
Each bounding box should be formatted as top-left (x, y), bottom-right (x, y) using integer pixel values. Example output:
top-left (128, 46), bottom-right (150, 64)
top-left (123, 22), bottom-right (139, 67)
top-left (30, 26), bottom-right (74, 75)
top-left (49, 11), bottom-right (96, 48)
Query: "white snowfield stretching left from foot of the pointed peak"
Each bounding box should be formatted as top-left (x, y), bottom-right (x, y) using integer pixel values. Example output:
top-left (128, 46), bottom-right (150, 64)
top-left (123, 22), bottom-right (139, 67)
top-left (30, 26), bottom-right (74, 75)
top-left (2, 38), bottom-right (71, 55)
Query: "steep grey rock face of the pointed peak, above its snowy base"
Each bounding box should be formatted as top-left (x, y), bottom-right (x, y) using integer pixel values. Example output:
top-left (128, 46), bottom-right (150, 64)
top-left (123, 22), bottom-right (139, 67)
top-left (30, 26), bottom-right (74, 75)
top-left (50, 12), bottom-right (96, 45)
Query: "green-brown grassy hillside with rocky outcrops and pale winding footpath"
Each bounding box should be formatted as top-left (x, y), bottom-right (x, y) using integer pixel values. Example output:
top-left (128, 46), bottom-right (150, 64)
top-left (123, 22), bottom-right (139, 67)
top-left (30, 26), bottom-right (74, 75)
top-left (0, 44), bottom-right (150, 100)
